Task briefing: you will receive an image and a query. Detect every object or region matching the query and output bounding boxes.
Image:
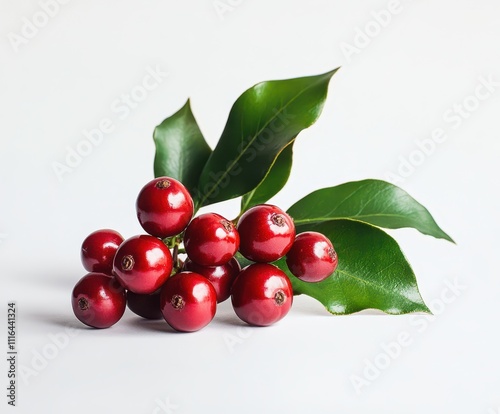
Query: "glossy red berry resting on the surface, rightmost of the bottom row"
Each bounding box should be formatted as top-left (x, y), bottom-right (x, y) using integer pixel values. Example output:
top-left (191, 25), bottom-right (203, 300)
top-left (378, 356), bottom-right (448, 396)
top-left (231, 263), bottom-right (293, 326)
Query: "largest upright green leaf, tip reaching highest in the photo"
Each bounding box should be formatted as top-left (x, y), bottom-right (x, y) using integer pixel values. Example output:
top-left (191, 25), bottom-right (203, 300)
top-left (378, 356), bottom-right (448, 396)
top-left (193, 69), bottom-right (337, 210)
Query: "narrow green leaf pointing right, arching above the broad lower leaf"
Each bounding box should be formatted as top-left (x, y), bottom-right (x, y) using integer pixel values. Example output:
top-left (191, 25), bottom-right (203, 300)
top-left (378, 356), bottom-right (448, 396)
top-left (287, 180), bottom-right (453, 242)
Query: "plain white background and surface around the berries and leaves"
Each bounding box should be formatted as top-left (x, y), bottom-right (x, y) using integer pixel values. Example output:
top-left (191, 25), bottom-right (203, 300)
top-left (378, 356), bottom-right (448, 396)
top-left (0, 0), bottom-right (500, 414)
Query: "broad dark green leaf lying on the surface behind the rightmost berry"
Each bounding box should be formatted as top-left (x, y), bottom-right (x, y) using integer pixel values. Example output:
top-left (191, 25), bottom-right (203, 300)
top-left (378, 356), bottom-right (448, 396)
top-left (274, 220), bottom-right (430, 315)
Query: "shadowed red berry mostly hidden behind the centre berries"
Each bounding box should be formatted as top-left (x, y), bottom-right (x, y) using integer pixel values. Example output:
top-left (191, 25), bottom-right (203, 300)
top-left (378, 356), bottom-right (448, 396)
top-left (184, 257), bottom-right (241, 303)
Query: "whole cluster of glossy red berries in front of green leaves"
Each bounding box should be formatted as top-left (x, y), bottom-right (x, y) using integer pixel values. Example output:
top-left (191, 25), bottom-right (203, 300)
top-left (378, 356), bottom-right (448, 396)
top-left (72, 177), bottom-right (338, 332)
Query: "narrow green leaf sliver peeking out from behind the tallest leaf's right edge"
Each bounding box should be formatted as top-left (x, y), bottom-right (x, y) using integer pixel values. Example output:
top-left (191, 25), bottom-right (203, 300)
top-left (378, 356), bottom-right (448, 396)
top-left (241, 142), bottom-right (293, 211)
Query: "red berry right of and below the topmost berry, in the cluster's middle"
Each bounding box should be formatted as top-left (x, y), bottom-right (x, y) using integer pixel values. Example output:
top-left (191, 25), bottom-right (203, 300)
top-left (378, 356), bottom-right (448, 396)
top-left (184, 213), bottom-right (240, 266)
